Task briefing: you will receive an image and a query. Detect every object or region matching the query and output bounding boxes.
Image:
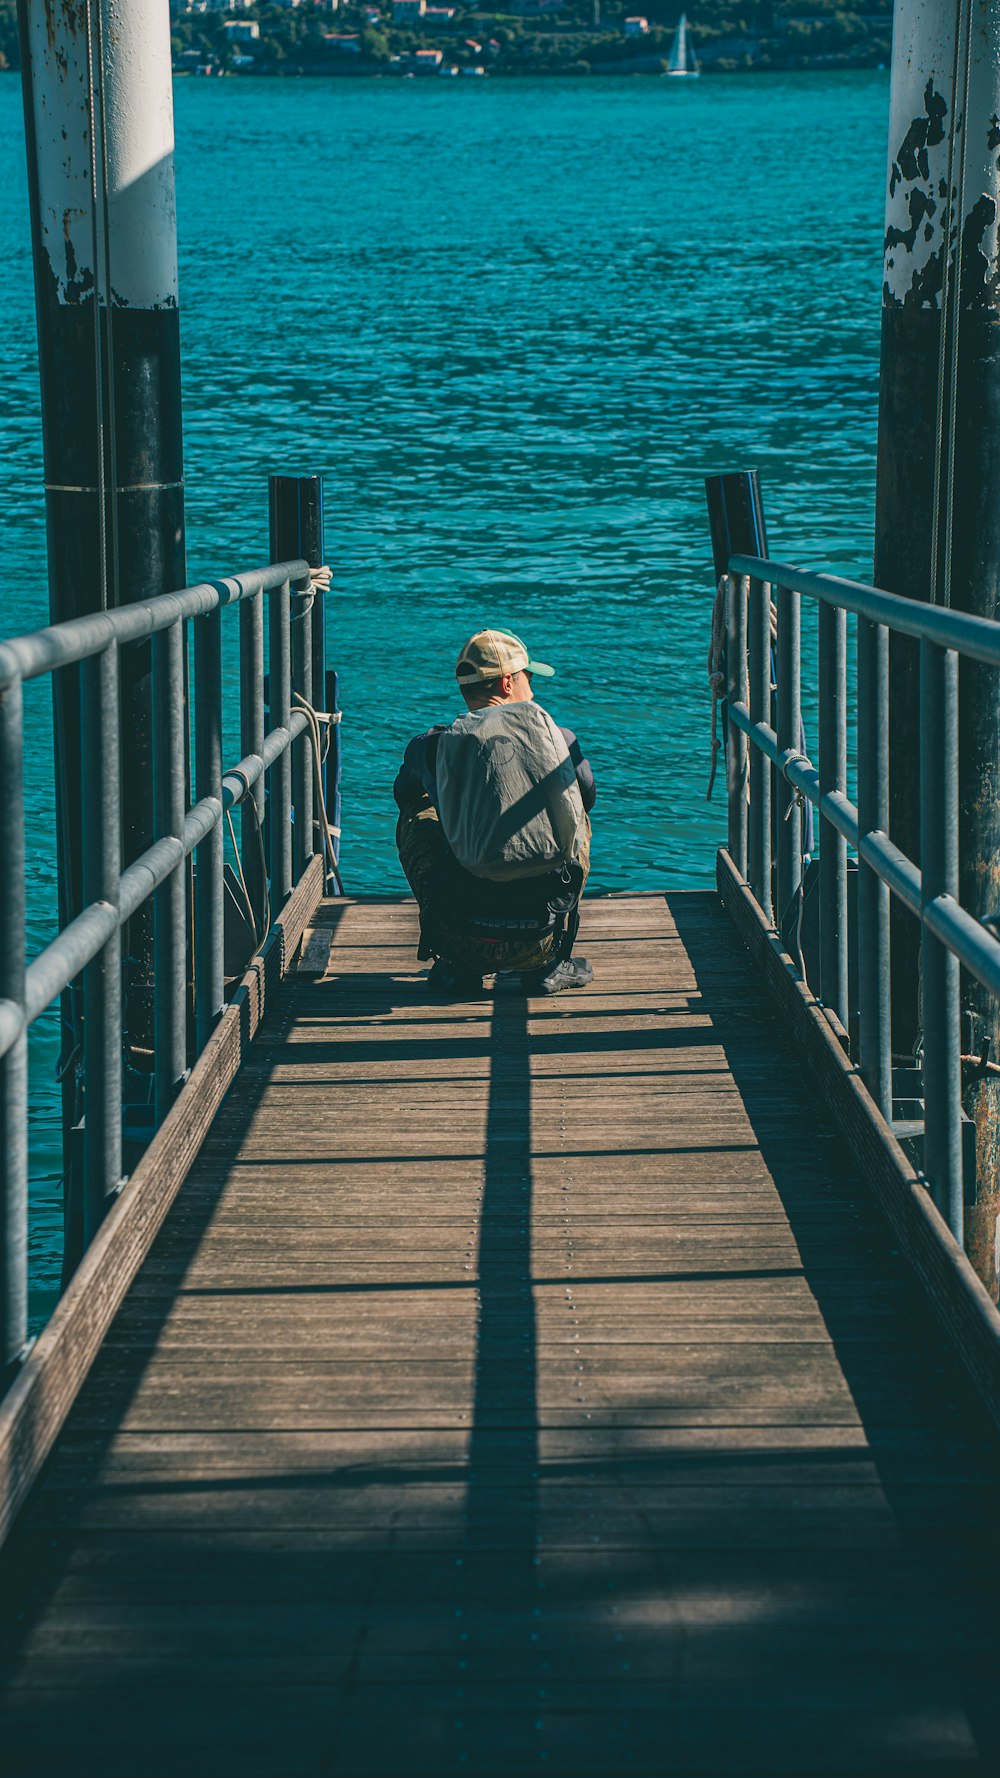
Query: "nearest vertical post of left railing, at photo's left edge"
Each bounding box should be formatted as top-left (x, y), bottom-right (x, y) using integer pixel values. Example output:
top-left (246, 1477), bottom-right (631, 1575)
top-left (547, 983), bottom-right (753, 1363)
top-left (0, 679), bottom-right (28, 1376)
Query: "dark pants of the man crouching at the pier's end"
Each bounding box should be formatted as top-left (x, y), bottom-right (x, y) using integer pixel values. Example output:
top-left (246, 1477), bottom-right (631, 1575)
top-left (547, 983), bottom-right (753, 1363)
top-left (395, 798), bottom-right (591, 976)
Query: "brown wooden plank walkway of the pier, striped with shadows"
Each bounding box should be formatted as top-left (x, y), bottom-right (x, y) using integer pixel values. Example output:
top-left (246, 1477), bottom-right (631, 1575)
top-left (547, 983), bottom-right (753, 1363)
top-left (0, 894), bottom-right (1000, 1778)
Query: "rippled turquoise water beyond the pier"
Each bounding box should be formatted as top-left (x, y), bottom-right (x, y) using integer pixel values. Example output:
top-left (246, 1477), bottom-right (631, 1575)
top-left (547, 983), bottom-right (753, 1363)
top-left (0, 73), bottom-right (888, 1303)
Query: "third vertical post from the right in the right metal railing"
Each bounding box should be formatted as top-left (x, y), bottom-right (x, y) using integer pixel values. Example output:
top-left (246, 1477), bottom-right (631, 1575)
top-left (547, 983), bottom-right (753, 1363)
top-left (819, 599), bottom-right (849, 1029)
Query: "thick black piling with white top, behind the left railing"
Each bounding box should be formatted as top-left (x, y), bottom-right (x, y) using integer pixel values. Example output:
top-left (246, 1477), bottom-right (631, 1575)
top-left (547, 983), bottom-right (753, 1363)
top-left (18, 0), bottom-right (185, 1223)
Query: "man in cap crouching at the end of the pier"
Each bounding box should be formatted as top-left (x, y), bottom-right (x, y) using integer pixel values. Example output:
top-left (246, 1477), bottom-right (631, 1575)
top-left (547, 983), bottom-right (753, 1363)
top-left (393, 629), bottom-right (596, 997)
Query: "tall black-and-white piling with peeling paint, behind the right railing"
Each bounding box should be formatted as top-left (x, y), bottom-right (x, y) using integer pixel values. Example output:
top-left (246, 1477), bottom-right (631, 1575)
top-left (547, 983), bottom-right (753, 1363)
top-left (875, 0), bottom-right (1000, 1294)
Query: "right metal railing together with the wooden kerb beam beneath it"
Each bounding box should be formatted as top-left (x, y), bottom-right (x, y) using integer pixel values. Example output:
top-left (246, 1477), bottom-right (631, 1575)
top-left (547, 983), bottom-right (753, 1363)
top-left (719, 555), bottom-right (1000, 1421)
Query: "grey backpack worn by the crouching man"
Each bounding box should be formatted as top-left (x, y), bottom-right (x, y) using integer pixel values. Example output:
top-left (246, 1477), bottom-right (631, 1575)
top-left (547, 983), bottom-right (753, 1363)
top-left (436, 704), bottom-right (584, 882)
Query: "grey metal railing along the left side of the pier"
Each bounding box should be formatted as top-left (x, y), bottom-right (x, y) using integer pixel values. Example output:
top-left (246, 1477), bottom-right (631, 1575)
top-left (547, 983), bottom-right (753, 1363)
top-left (0, 560), bottom-right (324, 1371)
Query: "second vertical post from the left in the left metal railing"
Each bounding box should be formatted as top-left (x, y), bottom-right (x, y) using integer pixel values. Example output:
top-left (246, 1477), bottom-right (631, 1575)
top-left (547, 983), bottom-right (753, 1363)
top-left (80, 642), bottom-right (121, 1246)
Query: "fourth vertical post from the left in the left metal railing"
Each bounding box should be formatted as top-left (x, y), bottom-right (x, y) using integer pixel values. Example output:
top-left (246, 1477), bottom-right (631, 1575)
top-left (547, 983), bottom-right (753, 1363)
top-left (194, 606), bottom-right (226, 1051)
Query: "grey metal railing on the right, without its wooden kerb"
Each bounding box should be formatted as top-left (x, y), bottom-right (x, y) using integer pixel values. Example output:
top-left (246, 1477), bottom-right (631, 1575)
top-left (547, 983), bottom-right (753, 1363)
top-left (726, 555), bottom-right (1000, 1243)
